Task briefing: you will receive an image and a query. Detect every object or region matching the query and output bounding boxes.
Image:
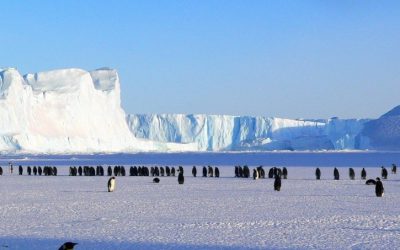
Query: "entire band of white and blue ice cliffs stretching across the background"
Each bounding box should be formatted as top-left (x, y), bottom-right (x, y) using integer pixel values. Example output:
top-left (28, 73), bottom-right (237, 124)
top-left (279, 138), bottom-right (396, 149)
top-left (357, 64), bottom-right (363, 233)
top-left (0, 68), bottom-right (394, 153)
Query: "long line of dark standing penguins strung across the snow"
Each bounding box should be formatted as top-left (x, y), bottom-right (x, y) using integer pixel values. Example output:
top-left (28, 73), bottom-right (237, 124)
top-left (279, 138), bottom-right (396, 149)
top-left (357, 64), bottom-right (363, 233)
top-left (0, 164), bottom-right (397, 197)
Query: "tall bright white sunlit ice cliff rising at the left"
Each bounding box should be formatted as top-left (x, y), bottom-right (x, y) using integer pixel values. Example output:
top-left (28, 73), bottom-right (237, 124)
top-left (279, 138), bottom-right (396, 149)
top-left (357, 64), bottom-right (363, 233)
top-left (0, 68), bottom-right (175, 153)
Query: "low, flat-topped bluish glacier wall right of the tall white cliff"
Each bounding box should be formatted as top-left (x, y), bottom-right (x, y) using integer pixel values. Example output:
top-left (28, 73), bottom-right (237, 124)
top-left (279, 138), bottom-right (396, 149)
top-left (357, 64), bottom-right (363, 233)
top-left (126, 114), bottom-right (368, 151)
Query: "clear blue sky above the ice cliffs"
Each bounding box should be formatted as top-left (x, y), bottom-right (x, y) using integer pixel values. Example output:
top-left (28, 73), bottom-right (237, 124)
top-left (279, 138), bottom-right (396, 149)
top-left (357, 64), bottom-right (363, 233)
top-left (0, 0), bottom-right (400, 118)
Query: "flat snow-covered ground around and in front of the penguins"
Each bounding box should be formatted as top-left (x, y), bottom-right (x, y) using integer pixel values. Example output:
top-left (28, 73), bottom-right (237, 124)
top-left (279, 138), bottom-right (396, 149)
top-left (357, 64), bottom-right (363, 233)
top-left (0, 166), bottom-right (400, 249)
